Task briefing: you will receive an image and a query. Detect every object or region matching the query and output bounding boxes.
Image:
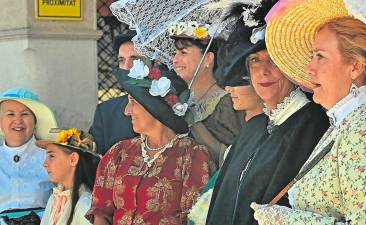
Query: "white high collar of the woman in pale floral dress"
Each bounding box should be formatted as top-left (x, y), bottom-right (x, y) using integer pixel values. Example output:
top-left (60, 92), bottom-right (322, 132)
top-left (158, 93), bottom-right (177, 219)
top-left (327, 85), bottom-right (366, 127)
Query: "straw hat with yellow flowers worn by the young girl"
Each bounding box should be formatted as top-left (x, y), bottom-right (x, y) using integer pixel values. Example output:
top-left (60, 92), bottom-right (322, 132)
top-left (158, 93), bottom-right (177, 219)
top-left (36, 128), bottom-right (101, 158)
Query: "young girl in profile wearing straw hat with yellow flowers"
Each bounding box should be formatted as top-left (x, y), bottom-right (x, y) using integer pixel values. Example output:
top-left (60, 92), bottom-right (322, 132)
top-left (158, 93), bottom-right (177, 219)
top-left (36, 128), bottom-right (100, 225)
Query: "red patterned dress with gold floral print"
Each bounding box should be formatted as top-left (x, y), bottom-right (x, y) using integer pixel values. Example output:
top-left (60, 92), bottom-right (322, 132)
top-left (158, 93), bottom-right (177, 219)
top-left (88, 137), bottom-right (213, 225)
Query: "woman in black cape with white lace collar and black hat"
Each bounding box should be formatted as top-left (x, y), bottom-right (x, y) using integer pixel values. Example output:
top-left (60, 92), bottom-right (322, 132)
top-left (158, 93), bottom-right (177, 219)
top-left (206, 0), bottom-right (329, 225)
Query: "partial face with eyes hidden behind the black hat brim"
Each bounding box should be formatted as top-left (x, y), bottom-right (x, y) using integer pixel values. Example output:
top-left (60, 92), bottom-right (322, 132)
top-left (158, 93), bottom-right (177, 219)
top-left (225, 85), bottom-right (261, 110)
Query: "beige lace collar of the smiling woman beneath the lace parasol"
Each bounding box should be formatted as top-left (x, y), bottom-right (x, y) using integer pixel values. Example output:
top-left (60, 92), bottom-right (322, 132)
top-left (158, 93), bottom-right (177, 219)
top-left (187, 89), bottom-right (227, 126)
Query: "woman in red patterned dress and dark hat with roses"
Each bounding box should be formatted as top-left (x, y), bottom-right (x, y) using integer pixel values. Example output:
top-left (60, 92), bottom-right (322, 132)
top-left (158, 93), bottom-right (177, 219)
top-left (89, 60), bottom-right (213, 225)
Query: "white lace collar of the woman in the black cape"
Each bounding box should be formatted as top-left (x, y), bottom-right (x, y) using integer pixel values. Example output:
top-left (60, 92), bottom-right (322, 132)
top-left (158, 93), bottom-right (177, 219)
top-left (263, 88), bottom-right (310, 133)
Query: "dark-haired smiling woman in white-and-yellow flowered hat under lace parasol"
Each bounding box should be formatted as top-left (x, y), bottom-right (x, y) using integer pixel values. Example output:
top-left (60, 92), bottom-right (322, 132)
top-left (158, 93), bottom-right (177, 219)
top-left (169, 21), bottom-right (241, 166)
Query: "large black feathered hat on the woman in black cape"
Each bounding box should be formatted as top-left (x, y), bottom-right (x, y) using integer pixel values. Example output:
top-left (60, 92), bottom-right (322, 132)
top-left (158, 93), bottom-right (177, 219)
top-left (214, 0), bottom-right (277, 86)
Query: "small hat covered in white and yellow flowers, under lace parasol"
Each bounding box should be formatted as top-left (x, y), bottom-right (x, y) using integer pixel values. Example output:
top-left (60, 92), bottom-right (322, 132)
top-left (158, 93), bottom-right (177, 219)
top-left (169, 21), bottom-right (215, 44)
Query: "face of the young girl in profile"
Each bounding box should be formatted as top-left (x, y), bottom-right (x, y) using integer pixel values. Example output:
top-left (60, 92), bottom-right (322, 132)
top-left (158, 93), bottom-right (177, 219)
top-left (43, 144), bottom-right (79, 189)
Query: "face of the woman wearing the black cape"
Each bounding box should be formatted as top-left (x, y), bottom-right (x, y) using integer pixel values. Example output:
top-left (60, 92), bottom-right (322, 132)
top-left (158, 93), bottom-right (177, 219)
top-left (248, 50), bottom-right (293, 108)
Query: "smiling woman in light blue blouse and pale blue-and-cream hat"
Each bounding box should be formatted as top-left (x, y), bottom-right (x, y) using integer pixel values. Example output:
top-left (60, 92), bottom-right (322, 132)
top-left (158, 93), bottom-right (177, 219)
top-left (0, 88), bottom-right (57, 224)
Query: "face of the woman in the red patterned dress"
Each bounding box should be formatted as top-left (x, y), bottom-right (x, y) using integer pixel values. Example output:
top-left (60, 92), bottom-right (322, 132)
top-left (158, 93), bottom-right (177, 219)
top-left (125, 95), bottom-right (158, 134)
